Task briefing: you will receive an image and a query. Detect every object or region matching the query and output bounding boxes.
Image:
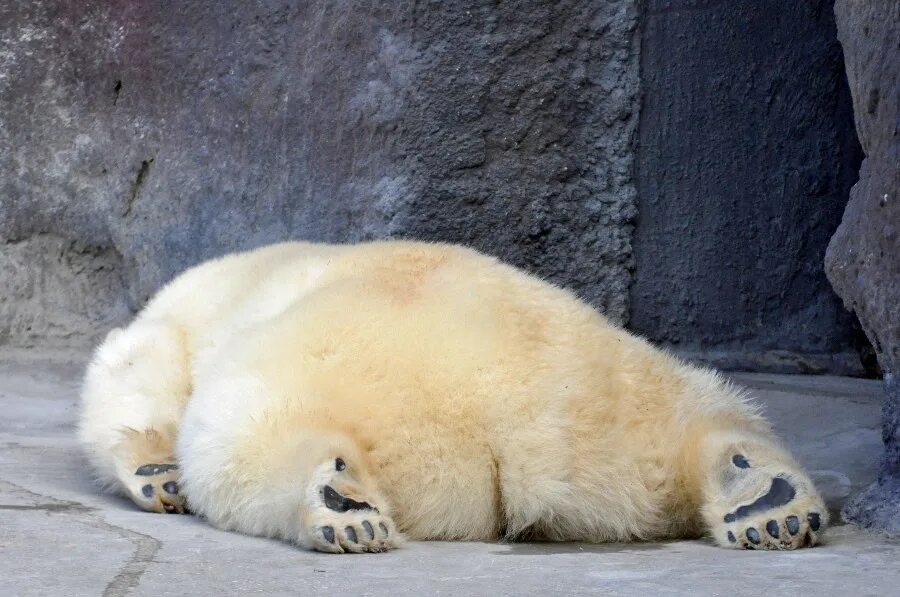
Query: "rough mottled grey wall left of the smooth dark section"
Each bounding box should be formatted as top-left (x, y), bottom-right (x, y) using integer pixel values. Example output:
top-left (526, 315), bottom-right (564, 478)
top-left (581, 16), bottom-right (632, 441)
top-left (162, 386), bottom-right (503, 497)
top-left (0, 0), bottom-right (639, 344)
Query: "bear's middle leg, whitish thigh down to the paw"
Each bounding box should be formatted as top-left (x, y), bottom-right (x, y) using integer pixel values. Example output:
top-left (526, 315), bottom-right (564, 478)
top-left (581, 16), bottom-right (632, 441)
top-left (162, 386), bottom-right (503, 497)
top-left (176, 392), bottom-right (403, 553)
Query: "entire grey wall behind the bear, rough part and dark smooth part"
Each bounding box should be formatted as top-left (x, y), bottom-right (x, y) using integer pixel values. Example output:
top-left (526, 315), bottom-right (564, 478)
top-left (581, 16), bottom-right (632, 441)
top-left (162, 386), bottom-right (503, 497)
top-left (0, 0), bottom-right (861, 373)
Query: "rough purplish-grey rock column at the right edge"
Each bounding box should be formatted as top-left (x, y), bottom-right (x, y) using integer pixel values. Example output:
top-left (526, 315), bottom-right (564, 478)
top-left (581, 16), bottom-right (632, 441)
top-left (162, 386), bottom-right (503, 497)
top-left (826, 0), bottom-right (900, 533)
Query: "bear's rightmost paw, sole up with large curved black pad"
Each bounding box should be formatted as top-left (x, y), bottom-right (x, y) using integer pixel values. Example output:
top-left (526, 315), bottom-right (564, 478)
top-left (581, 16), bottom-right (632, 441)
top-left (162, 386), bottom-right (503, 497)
top-left (701, 430), bottom-right (828, 550)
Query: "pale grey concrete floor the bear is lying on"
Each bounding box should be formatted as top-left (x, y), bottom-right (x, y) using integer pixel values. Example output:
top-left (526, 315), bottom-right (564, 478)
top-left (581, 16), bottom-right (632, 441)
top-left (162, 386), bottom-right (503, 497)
top-left (0, 353), bottom-right (900, 596)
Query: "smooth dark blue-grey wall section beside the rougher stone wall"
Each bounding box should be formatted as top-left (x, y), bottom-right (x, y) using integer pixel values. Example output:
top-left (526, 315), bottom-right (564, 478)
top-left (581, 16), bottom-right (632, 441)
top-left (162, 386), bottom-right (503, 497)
top-left (631, 0), bottom-right (861, 373)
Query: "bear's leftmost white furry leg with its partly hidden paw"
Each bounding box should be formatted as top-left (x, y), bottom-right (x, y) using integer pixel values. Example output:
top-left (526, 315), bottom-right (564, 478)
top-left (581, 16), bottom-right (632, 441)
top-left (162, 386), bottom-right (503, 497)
top-left (79, 321), bottom-right (191, 513)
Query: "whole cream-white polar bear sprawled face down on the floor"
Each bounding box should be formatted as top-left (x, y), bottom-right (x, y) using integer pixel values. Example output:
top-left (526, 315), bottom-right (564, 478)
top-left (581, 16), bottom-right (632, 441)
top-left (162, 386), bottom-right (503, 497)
top-left (80, 242), bottom-right (827, 553)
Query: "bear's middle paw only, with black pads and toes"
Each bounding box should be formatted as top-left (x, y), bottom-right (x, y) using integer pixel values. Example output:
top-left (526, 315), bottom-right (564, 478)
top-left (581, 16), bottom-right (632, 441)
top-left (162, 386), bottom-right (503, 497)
top-left (300, 457), bottom-right (402, 553)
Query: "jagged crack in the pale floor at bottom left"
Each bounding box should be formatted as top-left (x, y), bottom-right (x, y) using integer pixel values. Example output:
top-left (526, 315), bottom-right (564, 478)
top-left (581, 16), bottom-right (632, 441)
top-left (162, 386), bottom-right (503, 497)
top-left (0, 479), bottom-right (162, 597)
